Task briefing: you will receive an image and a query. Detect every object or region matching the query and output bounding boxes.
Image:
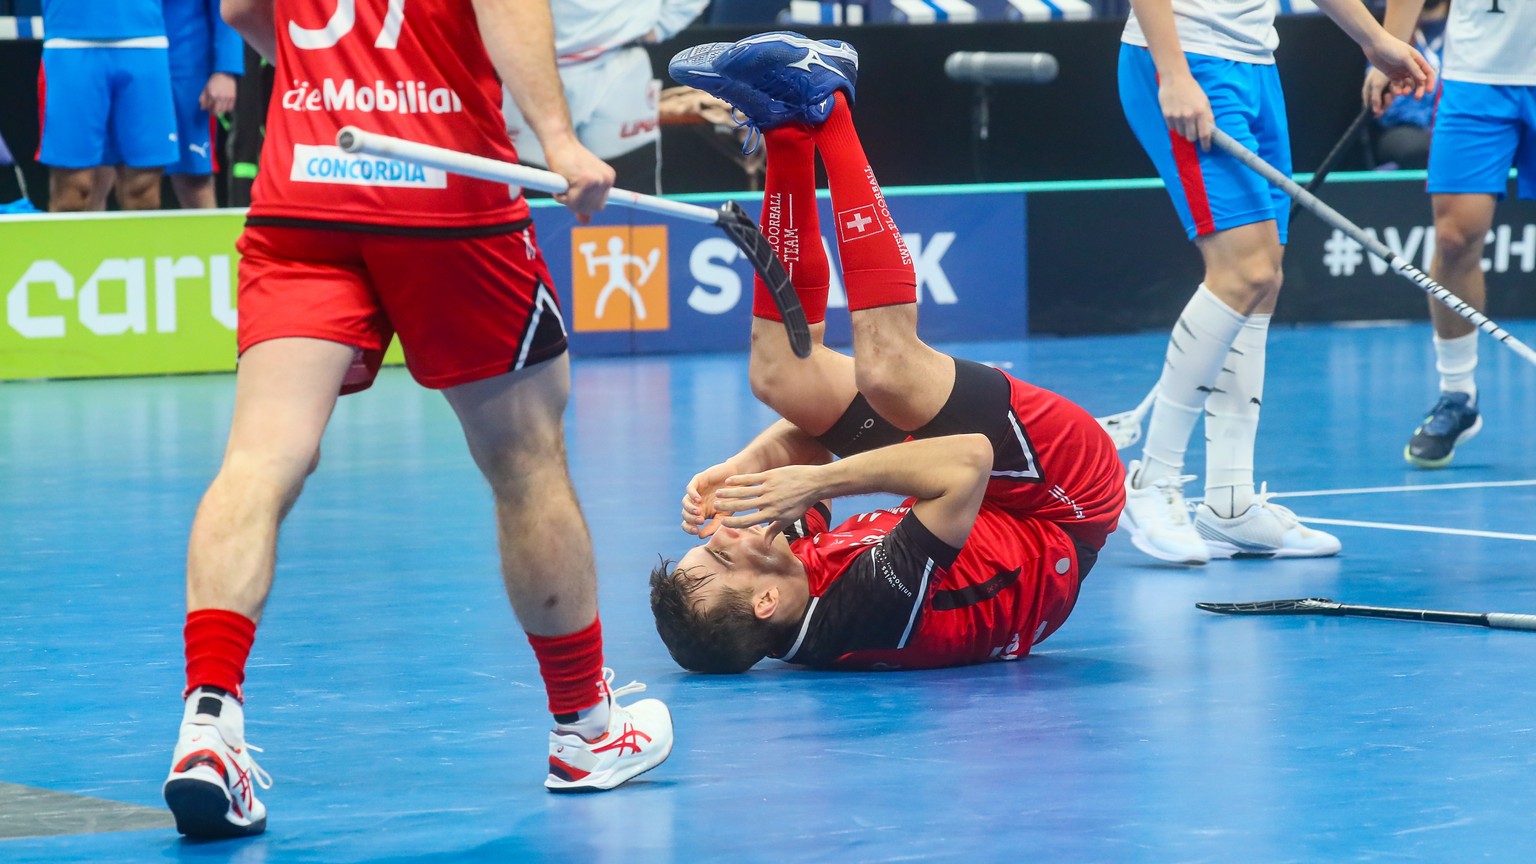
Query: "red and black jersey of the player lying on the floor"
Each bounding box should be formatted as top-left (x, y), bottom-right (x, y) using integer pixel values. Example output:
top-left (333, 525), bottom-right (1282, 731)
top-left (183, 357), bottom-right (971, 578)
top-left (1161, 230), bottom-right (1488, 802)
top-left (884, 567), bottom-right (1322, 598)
top-left (779, 501), bottom-right (1080, 669)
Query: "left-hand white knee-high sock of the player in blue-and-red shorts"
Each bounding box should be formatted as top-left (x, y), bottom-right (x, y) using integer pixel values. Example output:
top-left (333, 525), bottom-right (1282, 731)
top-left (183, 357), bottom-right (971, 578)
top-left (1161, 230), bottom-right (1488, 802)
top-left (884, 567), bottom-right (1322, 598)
top-left (1130, 283), bottom-right (1244, 489)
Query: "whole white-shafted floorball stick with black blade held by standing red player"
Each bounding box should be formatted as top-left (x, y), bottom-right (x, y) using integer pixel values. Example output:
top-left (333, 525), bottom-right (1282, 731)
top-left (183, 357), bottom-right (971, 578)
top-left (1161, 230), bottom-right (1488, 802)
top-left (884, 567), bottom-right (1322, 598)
top-left (336, 126), bottom-right (811, 357)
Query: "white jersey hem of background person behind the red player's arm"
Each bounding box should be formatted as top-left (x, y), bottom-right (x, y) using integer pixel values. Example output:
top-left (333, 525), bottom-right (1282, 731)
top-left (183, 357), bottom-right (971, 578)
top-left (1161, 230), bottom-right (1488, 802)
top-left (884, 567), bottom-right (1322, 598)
top-left (550, 0), bottom-right (710, 66)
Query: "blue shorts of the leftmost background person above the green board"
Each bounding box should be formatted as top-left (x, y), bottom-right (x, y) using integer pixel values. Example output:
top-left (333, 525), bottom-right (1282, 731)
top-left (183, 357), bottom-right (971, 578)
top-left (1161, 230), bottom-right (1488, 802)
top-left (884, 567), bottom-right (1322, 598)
top-left (38, 48), bottom-right (177, 168)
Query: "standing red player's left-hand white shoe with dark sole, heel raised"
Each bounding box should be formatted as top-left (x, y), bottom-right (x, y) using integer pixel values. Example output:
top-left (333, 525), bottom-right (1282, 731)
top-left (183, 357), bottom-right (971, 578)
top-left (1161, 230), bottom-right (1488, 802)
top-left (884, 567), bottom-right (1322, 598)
top-left (164, 687), bottom-right (272, 839)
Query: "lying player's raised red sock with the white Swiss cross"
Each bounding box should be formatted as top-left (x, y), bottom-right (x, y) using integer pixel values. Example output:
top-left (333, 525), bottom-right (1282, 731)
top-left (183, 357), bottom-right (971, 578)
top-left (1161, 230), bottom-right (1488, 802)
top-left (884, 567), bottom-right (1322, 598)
top-left (813, 92), bottom-right (917, 312)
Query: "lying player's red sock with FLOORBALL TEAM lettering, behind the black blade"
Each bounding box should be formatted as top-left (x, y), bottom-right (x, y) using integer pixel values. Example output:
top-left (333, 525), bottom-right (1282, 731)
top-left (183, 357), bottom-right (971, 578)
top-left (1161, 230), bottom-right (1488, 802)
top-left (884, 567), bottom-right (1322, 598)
top-left (753, 123), bottom-right (831, 324)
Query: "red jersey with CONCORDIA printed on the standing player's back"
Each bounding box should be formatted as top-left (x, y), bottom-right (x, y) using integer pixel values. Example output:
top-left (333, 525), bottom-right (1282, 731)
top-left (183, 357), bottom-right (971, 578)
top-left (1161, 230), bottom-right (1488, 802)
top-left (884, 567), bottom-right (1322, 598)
top-left (250, 0), bottom-right (528, 228)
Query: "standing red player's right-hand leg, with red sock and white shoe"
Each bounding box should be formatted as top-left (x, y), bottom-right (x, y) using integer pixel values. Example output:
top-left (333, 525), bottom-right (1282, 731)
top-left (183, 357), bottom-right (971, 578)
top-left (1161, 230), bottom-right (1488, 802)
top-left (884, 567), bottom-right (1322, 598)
top-left (444, 354), bottom-right (671, 792)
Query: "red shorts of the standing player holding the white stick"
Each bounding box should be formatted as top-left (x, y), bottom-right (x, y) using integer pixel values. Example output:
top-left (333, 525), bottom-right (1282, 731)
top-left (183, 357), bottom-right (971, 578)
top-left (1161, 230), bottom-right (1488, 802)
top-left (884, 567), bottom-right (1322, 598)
top-left (237, 224), bottom-right (565, 394)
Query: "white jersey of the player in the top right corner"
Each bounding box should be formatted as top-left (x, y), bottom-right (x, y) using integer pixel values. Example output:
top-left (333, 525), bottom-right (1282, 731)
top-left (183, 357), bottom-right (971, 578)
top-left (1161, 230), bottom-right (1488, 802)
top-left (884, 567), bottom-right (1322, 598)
top-left (1442, 0), bottom-right (1536, 86)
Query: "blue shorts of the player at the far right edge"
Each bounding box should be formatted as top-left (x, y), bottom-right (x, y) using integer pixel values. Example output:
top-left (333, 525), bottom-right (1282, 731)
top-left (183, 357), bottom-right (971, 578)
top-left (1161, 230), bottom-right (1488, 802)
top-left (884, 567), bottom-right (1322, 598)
top-left (1428, 81), bottom-right (1536, 198)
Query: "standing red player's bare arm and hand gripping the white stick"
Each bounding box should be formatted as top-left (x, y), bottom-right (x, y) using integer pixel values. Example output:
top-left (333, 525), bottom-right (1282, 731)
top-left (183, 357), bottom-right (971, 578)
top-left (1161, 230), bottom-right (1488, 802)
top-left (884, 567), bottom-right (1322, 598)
top-left (473, 0), bottom-right (613, 224)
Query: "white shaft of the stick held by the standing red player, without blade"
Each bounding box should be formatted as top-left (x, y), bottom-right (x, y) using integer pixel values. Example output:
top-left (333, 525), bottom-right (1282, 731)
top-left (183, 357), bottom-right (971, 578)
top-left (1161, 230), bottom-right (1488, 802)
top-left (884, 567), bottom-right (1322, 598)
top-left (336, 126), bottom-right (719, 224)
